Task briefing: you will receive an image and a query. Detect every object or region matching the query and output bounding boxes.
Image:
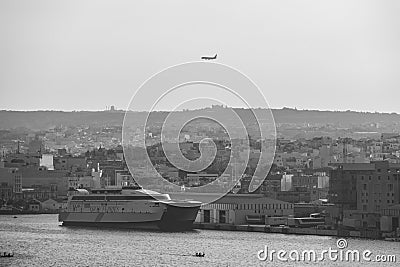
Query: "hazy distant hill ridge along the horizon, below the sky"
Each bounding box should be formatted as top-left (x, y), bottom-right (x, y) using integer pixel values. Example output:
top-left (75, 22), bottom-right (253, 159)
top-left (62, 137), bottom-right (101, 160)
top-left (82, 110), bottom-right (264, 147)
top-left (0, 108), bottom-right (400, 130)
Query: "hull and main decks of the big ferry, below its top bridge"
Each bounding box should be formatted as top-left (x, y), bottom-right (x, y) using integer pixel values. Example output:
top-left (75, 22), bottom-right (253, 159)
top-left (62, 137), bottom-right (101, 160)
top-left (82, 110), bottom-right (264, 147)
top-left (59, 189), bottom-right (200, 231)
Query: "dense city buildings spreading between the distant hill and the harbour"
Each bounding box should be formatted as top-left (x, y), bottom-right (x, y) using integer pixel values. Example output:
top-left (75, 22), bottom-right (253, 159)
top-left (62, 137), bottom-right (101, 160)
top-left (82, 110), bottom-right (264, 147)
top-left (0, 127), bottom-right (400, 239)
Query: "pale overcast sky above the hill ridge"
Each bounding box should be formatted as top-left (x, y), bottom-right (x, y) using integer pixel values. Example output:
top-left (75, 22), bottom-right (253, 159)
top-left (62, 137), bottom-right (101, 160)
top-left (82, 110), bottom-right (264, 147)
top-left (0, 0), bottom-right (400, 113)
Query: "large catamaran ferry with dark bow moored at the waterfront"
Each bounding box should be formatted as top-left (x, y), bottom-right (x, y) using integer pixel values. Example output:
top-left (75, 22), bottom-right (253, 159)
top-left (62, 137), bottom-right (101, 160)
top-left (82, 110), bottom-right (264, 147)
top-left (58, 186), bottom-right (201, 231)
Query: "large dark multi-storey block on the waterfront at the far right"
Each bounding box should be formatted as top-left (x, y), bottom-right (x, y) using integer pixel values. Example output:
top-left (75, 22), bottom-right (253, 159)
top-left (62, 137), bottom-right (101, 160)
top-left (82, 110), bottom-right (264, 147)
top-left (329, 161), bottom-right (400, 229)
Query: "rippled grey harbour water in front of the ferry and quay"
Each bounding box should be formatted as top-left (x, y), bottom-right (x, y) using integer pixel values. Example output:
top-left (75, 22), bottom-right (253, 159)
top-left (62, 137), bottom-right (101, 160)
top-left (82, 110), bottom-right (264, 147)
top-left (0, 215), bottom-right (400, 266)
